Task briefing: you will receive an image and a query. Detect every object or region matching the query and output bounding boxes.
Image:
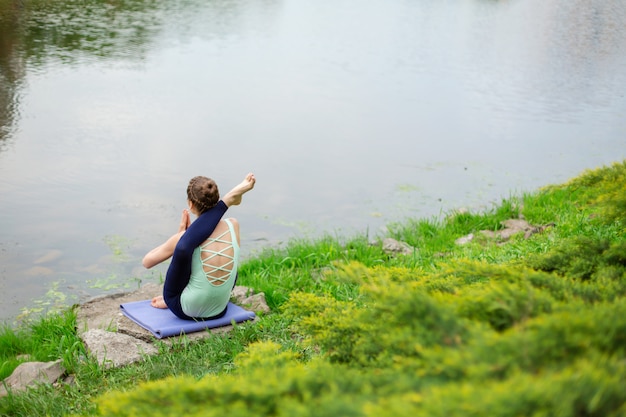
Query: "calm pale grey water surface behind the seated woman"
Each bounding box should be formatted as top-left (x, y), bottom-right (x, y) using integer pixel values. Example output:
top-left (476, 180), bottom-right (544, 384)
top-left (0, 0), bottom-right (626, 320)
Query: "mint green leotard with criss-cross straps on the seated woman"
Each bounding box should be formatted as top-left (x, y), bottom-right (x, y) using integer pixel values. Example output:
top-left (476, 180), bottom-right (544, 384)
top-left (180, 219), bottom-right (239, 317)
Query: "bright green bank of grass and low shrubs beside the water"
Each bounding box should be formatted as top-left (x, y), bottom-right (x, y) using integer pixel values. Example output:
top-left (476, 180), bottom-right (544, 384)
top-left (0, 162), bottom-right (626, 416)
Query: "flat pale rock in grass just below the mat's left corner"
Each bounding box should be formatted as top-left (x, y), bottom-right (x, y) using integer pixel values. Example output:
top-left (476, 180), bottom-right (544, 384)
top-left (81, 329), bottom-right (159, 368)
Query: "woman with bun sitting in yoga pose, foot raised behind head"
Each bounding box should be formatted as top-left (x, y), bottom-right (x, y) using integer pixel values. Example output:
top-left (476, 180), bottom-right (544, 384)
top-left (143, 173), bottom-right (256, 320)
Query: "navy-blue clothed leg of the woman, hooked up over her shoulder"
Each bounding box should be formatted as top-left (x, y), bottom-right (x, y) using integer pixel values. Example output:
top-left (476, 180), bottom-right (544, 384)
top-left (163, 200), bottom-right (228, 320)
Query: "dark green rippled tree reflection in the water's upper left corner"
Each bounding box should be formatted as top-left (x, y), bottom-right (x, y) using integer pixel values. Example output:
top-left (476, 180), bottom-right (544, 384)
top-left (0, 0), bottom-right (160, 150)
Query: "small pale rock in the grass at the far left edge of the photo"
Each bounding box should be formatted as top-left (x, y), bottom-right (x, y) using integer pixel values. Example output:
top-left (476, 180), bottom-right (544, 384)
top-left (0, 360), bottom-right (65, 397)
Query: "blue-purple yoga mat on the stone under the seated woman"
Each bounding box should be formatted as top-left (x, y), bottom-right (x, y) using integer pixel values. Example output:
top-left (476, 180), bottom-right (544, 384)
top-left (120, 300), bottom-right (256, 339)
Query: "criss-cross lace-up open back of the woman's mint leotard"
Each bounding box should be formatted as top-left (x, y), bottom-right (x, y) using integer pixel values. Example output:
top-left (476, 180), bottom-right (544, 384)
top-left (200, 219), bottom-right (239, 285)
